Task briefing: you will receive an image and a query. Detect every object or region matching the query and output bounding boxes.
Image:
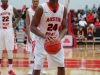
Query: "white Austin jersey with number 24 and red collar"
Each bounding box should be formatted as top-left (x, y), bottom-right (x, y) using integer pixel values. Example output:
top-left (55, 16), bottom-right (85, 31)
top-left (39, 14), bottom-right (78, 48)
top-left (40, 2), bottom-right (64, 36)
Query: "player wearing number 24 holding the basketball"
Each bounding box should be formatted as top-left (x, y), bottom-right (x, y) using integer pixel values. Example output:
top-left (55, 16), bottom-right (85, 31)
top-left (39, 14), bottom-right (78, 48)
top-left (30, 0), bottom-right (67, 75)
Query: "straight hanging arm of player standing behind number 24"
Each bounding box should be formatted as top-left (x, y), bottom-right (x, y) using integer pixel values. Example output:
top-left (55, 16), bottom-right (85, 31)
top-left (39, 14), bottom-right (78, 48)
top-left (26, 10), bottom-right (32, 43)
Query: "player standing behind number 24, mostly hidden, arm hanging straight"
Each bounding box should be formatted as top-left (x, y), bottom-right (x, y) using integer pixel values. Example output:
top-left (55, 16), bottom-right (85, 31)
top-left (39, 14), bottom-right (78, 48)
top-left (26, 0), bottom-right (46, 74)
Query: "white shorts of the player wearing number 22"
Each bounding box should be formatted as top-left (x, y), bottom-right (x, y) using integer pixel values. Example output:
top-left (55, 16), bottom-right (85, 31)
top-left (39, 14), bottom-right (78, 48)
top-left (0, 28), bottom-right (14, 50)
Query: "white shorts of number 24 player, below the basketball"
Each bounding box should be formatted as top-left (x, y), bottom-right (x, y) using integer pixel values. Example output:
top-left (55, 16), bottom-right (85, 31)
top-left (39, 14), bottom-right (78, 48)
top-left (34, 36), bottom-right (64, 70)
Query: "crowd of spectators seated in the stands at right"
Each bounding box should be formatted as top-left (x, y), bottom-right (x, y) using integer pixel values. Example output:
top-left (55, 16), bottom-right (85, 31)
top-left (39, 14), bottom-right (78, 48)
top-left (71, 4), bottom-right (100, 42)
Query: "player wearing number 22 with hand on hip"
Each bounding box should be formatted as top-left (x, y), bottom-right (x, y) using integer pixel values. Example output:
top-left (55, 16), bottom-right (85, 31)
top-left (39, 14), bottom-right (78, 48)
top-left (0, 0), bottom-right (20, 75)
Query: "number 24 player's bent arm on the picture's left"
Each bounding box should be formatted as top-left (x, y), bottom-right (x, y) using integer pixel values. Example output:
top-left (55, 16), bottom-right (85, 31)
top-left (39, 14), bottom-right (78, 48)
top-left (30, 6), bottom-right (49, 39)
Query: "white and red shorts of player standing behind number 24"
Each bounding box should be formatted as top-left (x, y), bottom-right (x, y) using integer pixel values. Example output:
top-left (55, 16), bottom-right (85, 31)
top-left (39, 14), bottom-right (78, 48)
top-left (26, 32), bottom-right (35, 52)
